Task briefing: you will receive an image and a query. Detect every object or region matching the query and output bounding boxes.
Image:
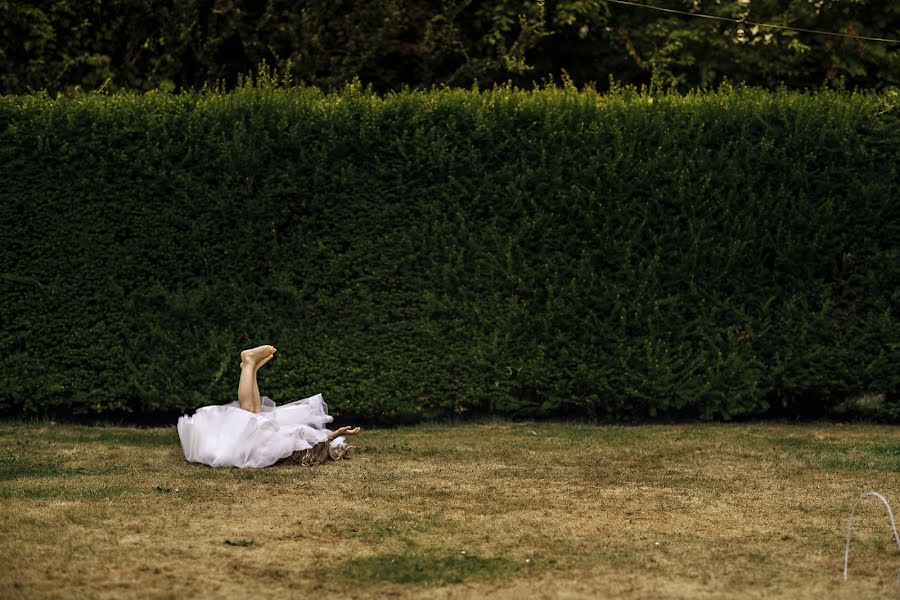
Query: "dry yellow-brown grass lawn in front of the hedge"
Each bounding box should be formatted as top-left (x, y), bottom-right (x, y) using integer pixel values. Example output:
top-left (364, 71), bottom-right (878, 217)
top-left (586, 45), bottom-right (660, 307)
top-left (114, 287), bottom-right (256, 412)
top-left (0, 422), bottom-right (900, 600)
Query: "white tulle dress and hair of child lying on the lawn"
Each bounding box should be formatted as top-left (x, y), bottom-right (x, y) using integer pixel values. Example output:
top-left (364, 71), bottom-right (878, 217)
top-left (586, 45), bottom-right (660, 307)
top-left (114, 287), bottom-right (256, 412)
top-left (178, 394), bottom-right (346, 468)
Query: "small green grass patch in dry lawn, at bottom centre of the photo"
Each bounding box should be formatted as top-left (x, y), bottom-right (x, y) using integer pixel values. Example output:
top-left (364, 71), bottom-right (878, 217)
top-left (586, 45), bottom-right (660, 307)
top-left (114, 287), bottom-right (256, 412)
top-left (340, 547), bottom-right (520, 584)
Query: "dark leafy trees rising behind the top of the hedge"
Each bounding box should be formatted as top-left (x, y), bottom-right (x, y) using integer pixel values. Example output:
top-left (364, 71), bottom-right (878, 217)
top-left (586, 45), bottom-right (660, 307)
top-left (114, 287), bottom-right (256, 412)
top-left (0, 0), bottom-right (900, 93)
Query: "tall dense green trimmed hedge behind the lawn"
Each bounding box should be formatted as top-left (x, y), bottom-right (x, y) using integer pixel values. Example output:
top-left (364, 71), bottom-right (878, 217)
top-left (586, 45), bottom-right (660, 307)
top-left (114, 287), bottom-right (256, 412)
top-left (0, 83), bottom-right (900, 422)
